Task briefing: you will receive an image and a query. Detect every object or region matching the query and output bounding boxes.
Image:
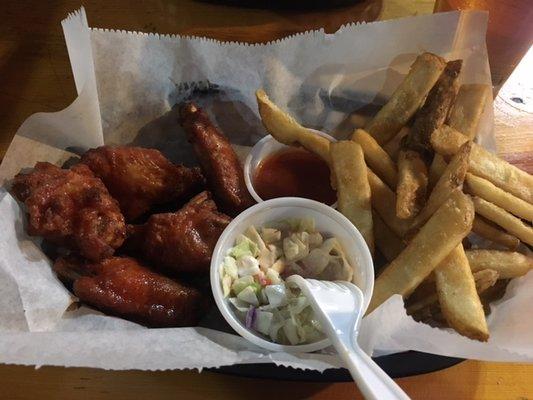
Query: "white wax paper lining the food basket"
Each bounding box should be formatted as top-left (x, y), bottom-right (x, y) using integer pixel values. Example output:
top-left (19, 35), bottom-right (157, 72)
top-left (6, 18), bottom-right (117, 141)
top-left (0, 9), bottom-right (533, 371)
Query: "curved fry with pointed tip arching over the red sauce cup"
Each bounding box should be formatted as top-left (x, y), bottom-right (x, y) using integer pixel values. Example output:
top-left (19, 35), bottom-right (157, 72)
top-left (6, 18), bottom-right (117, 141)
top-left (255, 89), bottom-right (330, 164)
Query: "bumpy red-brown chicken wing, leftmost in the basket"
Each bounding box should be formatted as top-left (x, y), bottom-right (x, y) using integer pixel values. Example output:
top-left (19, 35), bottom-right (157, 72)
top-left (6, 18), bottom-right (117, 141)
top-left (12, 162), bottom-right (126, 261)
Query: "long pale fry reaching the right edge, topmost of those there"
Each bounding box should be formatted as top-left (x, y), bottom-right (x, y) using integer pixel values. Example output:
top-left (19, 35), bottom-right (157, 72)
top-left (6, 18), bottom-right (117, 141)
top-left (431, 125), bottom-right (533, 203)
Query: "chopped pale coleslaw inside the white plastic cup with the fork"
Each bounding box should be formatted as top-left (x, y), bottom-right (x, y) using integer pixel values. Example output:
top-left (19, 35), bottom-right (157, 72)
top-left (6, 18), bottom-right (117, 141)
top-left (220, 218), bottom-right (353, 345)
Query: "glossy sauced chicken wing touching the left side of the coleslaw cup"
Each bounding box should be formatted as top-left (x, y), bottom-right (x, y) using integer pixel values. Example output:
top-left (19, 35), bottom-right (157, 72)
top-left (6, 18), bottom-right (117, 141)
top-left (126, 192), bottom-right (231, 276)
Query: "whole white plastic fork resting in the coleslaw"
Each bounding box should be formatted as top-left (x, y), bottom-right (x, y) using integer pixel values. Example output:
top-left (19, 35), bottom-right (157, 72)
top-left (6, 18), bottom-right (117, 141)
top-left (287, 275), bottom-right (409, 400)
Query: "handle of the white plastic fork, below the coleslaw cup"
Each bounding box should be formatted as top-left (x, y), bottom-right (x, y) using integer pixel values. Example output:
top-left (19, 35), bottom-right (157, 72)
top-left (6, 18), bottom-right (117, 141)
top-left (335, 341), bottom-right (409, 400)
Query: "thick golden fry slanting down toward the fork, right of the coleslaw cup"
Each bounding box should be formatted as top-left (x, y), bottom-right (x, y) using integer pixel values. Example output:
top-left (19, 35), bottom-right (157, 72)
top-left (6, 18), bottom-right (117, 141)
top-left (367, 192), bottom-right (474, 313)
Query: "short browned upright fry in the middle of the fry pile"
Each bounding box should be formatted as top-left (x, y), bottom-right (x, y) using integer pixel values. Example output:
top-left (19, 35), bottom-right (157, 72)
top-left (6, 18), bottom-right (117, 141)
top-left (396, 150), bottom-right (428, 219)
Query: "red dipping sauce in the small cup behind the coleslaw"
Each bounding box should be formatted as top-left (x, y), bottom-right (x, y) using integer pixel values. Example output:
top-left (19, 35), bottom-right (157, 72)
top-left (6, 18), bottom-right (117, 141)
top-left (254, 148), bottom-right (337, 205)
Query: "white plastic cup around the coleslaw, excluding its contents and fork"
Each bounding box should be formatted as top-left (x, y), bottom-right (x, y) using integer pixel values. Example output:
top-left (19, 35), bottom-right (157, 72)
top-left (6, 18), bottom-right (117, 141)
top-left (210, 197), bottom-right (374, 353)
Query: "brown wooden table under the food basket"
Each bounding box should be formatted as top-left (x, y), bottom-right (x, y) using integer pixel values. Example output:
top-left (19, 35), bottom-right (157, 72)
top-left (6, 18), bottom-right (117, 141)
top-left (0, 0), bottom-right (533, 400)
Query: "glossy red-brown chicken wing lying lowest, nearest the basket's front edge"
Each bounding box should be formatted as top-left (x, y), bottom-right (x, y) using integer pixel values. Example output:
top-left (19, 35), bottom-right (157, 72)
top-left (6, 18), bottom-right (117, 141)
top-left (54, 257), bottom-right (209, 327)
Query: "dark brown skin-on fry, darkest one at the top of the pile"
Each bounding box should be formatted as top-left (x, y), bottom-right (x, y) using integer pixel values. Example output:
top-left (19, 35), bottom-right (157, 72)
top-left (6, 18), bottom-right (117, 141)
top-left (402, 60), bottom-right (463, 162)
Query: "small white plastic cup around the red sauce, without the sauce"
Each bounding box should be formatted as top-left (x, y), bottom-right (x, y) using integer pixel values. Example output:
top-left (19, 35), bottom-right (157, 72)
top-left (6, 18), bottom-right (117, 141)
top-left (244, 129), bottom-right (337, 208)
